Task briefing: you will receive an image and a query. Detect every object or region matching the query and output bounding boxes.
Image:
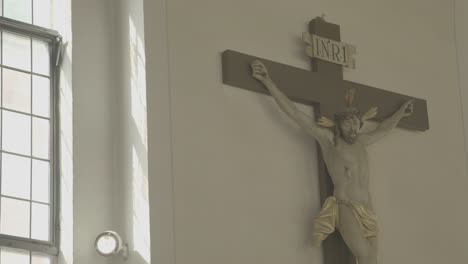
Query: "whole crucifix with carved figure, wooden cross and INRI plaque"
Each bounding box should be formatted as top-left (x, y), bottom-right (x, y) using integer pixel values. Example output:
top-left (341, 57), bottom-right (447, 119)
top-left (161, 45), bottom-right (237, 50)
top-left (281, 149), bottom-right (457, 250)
top-left (222, 18), bottom-right (429, 264)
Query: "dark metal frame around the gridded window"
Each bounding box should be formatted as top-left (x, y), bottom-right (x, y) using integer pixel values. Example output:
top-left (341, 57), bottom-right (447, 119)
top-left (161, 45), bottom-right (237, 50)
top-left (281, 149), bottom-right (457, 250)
top-left (0, 17), bottom-right (62, 256)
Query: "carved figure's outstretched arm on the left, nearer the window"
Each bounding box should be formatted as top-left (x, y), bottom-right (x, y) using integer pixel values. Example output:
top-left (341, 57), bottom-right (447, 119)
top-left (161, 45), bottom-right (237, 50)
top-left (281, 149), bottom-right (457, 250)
top-left (251, 61), bottom-right (333, 149)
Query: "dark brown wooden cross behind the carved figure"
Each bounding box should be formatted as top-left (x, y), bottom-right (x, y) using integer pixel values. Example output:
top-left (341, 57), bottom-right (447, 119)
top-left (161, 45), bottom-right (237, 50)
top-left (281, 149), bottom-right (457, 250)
top-left (222, 18), bottom-right (429, 264)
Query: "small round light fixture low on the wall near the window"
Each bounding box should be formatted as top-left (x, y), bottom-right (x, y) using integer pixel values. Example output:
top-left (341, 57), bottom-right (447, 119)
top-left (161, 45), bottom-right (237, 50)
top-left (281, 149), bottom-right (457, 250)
top-left (94, 231), bottom-right (128, 258)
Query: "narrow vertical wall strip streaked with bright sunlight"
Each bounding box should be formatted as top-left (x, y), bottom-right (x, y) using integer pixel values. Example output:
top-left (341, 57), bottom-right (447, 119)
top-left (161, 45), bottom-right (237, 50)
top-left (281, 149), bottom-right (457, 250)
top-left (113, 0), bottom-right (151, 264)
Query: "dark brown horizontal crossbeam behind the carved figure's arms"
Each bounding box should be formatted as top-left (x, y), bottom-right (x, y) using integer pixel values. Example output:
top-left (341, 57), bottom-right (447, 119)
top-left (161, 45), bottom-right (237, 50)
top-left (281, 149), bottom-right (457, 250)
top-left (222, 50), bottom-right (429, 131)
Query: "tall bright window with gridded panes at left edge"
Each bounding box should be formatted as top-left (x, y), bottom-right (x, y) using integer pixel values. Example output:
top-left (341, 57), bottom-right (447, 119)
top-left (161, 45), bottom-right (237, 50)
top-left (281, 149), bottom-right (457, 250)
top-left (0, 0), bottom-right (61, 264)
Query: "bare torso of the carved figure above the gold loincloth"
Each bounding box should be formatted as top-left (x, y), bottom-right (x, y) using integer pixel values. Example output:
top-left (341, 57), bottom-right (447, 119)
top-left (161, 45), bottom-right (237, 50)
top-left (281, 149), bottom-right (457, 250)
top-left (322, 138), bottom-right (369, 206)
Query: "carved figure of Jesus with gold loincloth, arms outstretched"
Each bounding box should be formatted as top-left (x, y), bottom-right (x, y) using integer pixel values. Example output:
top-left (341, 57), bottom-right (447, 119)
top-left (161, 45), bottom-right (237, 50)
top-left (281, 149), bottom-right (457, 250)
top-left (251, 61), bottom-right (413, 264)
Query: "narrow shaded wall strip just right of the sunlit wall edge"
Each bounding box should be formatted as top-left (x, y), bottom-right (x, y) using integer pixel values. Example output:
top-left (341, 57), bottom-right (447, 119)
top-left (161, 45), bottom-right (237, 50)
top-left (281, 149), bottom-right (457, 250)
top-left (144, 0), bottom-right (176, 264)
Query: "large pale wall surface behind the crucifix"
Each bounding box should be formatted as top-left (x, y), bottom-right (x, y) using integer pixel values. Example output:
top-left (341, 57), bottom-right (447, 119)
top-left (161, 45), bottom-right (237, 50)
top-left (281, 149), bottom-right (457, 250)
top-left (145, 0), bottom-right (468, 264)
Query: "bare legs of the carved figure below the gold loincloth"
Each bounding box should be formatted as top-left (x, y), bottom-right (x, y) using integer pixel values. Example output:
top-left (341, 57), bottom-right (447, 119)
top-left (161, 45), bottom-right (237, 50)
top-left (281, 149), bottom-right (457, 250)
top-left (338, 204), bottom-right (377, 264)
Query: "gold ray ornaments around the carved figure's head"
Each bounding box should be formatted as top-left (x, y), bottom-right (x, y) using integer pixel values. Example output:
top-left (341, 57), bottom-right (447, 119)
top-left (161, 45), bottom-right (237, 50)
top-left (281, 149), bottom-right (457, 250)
top-left (317, 89), bottom-right (377, 128)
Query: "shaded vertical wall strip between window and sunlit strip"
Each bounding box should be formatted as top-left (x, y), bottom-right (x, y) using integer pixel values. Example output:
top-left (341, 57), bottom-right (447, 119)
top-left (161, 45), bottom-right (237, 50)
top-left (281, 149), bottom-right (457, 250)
top-left (72, 0), bottom-right (116, 264)
